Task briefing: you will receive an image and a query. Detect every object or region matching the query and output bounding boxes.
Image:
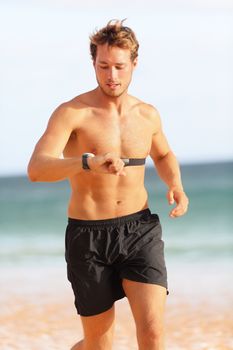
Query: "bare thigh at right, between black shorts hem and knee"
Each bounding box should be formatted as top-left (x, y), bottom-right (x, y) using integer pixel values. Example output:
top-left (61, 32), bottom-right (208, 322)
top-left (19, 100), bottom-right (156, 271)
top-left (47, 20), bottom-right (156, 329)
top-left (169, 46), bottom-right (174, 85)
top-left (122, 278), bottom-right (167, 328)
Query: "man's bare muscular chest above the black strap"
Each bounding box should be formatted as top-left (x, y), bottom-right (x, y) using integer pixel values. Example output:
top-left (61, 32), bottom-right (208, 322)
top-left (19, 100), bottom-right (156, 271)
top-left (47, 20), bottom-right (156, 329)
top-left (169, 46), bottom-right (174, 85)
top-left (65, 116), bottom-right (152, 158)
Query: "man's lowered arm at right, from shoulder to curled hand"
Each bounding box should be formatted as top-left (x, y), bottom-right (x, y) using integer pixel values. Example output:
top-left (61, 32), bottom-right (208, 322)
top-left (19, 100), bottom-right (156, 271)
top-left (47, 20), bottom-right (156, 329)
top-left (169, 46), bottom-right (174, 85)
top-left (150, 106), bottom-right (189, 218)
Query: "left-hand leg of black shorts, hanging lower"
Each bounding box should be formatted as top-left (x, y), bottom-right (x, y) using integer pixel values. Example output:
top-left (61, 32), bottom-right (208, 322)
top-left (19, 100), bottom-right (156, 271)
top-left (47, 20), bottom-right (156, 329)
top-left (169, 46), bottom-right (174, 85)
top-left (65, 223), bottom-right (125, 317)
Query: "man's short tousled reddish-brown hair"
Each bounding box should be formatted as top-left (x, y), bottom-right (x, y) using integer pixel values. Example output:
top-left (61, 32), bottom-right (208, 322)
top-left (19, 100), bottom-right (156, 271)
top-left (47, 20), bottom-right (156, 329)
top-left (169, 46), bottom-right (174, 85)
top-left (90, 19), bottom-right (139, 61)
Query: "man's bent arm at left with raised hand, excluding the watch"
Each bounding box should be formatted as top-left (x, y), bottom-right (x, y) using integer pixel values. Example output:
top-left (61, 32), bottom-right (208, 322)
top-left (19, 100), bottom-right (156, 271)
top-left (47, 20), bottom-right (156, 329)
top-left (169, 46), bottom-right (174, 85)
top-left (28, 104), bottom-right (126, 182)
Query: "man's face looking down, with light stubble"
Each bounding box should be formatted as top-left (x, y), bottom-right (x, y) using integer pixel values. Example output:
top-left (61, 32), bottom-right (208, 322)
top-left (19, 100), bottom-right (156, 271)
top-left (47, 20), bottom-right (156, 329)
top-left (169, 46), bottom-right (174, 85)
top-left (94, 44), bottom-right (137, 97)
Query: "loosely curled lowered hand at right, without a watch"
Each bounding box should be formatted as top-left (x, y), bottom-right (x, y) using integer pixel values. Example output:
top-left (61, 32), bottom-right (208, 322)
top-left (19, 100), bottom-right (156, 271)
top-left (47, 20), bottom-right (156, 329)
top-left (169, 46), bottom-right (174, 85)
top-left (167, 188), bottom-right (189, 218)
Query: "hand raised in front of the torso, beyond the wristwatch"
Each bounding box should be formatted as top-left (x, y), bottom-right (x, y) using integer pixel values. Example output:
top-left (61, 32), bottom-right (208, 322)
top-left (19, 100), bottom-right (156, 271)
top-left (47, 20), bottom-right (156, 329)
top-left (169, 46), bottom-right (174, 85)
top-left (88, 153), bottom-right (126, 176)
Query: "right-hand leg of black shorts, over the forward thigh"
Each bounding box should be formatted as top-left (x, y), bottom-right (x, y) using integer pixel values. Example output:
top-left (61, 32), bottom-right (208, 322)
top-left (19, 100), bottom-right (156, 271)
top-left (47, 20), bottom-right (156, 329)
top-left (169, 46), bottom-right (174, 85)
top-left (117, 214), bottom-right (169, 294)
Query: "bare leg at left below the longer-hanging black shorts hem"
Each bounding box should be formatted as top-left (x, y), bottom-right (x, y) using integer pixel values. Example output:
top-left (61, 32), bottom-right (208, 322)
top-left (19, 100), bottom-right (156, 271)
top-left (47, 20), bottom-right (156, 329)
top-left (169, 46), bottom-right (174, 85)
top-left (71, 305), bottom-right (115, 350)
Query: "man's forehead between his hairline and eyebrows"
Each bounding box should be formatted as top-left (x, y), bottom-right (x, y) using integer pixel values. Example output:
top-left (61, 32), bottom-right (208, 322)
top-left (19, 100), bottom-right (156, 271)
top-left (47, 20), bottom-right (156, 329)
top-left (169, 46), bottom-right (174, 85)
top-left (96, 44), bottom-right (130, 63)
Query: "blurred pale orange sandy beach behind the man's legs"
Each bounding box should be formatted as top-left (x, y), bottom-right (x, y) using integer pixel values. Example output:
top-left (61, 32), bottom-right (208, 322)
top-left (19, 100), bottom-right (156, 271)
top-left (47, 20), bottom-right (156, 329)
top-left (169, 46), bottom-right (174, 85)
top-left (0, 264), bottom-right (233, 350)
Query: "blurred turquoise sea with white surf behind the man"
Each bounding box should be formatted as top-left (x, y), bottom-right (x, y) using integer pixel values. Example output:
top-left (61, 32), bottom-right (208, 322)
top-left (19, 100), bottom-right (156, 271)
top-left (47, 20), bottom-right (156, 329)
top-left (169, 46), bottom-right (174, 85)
top-left (0, 162), bottom-right (233, 266)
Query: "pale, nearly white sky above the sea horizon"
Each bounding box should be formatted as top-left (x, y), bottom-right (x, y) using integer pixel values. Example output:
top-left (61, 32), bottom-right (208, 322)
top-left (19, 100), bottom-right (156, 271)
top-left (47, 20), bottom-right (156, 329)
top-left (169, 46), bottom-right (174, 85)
top-left (0, 0), bottom-right (233, 176)
